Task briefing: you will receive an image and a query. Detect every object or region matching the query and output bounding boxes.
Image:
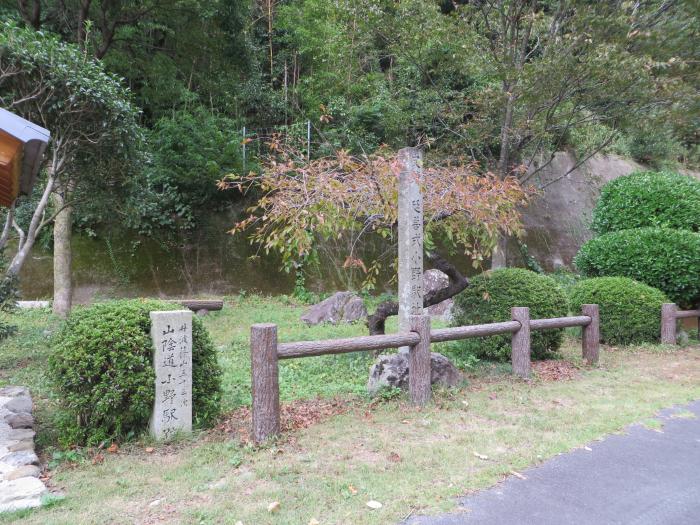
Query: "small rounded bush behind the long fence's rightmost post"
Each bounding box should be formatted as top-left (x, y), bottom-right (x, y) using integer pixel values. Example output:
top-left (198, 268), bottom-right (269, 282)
top-left (569, 277), bottom-right (669, 345)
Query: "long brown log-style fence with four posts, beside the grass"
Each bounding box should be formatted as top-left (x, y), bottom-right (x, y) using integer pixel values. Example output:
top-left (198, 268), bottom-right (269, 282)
top-left (250, 304), bottom-right (600, 443)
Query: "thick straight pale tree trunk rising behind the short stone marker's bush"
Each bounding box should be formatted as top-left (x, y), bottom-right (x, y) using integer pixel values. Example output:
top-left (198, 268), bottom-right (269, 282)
top-left (53, 192), bottom-right (73, 317)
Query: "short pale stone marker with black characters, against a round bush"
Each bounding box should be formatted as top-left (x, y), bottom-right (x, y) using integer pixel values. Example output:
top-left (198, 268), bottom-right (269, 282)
top-left (150, 310), bottom-right (192, 440)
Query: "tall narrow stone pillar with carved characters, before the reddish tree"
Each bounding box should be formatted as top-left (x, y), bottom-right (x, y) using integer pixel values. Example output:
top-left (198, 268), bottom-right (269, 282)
top-left (398, 148), bottom-right (423, 352)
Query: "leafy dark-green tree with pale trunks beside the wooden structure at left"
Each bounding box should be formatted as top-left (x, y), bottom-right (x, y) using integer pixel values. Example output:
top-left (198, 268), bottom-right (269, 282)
top-left (0, 21), bottom-right (141, 315)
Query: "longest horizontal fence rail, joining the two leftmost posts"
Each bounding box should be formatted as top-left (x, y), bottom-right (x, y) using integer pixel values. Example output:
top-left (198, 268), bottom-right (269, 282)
top-left (277, 332), bottom-right (420, 359)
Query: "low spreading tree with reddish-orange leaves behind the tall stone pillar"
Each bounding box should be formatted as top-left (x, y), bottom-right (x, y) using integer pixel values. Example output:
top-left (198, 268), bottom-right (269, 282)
top-left (220, 141), bottom-right (530, 334)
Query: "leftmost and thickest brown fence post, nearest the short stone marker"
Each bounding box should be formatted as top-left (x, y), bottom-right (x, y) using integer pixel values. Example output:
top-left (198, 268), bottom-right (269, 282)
top-left (250, 324), bottom-right (280, 443)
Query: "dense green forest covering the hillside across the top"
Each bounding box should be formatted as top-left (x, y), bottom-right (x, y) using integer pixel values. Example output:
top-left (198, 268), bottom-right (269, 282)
top-left (0, 0), bottom-right (700, 308)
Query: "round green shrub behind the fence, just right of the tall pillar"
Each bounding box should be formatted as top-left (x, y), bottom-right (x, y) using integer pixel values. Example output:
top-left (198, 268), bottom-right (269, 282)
top-left (453, 268), bottom-right (568, 361)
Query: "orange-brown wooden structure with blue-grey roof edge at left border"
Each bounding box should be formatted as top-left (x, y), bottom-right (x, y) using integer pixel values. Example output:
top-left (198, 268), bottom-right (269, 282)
top-left (0, 109), bottom-right (50, 207)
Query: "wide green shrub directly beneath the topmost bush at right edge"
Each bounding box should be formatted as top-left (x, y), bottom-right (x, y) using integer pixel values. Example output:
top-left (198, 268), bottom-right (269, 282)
top-left (574, 228), bottom-right (700, 308)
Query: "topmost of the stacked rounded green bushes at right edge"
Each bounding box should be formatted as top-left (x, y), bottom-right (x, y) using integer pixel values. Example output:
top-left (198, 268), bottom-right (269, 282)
top-left (592, 171), bottom-right (700, 233)
